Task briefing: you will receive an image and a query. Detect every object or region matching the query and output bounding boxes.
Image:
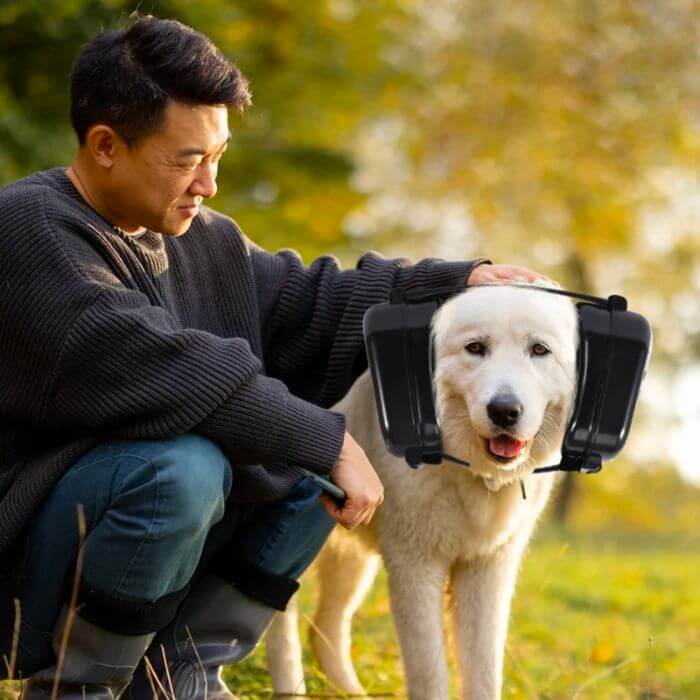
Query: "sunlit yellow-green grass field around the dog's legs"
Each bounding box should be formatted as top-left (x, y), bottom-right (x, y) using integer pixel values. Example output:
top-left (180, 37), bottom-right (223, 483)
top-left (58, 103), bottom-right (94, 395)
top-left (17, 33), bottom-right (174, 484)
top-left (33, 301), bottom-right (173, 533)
top-left (0, 474), bottom-right (700, 700)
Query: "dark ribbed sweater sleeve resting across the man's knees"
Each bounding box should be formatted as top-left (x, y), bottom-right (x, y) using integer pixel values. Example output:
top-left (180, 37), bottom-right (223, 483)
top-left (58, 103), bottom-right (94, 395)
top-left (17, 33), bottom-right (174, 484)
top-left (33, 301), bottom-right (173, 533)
top-left (43, 288), bottom-right (345, 473)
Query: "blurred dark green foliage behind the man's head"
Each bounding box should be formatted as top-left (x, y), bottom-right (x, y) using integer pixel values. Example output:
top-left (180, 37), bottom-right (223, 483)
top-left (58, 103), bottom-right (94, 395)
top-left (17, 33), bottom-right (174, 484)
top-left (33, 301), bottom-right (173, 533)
top-left (0, 0), bottom-right (410, 257)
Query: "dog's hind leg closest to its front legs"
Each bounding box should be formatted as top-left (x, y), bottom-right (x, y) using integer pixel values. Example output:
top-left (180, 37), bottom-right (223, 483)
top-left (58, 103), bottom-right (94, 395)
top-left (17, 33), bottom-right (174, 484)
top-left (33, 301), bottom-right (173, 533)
top-left (309, 532), bottom-right (379, 695)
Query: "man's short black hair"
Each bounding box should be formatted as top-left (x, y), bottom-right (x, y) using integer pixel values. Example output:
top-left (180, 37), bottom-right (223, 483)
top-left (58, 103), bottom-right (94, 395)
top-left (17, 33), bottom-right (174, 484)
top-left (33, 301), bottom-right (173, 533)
top-left (71, 15), bottom-right (251, 147)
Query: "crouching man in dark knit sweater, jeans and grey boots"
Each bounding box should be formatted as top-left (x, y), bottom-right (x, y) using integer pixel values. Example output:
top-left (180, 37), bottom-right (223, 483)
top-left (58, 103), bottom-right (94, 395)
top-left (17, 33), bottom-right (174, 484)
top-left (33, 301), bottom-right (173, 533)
top-left (0, 12), bottom-right (548, 700)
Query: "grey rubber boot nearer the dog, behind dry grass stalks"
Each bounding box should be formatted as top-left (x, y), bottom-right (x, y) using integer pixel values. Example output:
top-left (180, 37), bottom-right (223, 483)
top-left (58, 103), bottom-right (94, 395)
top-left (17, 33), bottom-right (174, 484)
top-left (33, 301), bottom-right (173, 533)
top-left (127, 575), bottom-right (276, 700)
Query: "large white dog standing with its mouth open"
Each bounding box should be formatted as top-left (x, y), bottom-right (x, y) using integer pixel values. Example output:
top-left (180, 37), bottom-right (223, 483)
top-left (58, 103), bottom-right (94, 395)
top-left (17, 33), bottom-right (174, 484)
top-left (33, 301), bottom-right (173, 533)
top-left (267, 286), bottom-right (578, 700)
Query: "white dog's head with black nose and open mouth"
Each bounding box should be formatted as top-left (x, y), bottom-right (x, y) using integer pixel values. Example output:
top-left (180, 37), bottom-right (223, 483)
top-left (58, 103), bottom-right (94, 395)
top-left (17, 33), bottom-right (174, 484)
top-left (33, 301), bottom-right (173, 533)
top-left (433, 285), bottom-right (578, 490)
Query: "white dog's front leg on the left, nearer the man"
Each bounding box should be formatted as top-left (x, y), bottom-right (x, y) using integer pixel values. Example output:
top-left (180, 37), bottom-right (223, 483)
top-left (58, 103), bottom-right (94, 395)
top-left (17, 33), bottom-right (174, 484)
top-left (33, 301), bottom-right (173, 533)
top-left (385, 545), bottom-right (449, 700)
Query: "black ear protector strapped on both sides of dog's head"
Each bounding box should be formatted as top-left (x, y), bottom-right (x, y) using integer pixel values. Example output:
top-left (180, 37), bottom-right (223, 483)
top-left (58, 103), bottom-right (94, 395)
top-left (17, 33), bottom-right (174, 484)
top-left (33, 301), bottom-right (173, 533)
top-left (363, 285), bottom-right (652, 474)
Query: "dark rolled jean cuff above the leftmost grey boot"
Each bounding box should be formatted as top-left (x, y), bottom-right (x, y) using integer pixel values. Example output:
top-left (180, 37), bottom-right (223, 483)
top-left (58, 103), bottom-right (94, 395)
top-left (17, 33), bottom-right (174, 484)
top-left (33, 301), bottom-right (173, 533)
top-left (71, 584), bottom-right (190, 636)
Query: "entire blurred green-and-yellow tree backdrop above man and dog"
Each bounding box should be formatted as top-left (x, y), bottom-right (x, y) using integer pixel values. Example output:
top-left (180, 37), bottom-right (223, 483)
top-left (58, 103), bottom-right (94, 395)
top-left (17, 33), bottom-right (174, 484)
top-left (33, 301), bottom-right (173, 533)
top-left (0, 0), bottom-right (700, 508)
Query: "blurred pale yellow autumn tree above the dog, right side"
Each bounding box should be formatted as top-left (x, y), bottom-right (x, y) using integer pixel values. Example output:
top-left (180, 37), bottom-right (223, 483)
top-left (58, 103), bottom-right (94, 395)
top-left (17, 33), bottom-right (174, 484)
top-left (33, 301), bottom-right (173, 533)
top-left (340, 0), bottom-right (700, 519)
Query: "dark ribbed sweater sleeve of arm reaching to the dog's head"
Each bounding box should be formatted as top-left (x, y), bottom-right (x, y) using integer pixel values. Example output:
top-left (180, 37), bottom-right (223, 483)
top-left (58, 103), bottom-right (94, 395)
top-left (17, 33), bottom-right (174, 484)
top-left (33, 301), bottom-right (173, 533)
top-left (251, 244), bottom-right (490, 406)
